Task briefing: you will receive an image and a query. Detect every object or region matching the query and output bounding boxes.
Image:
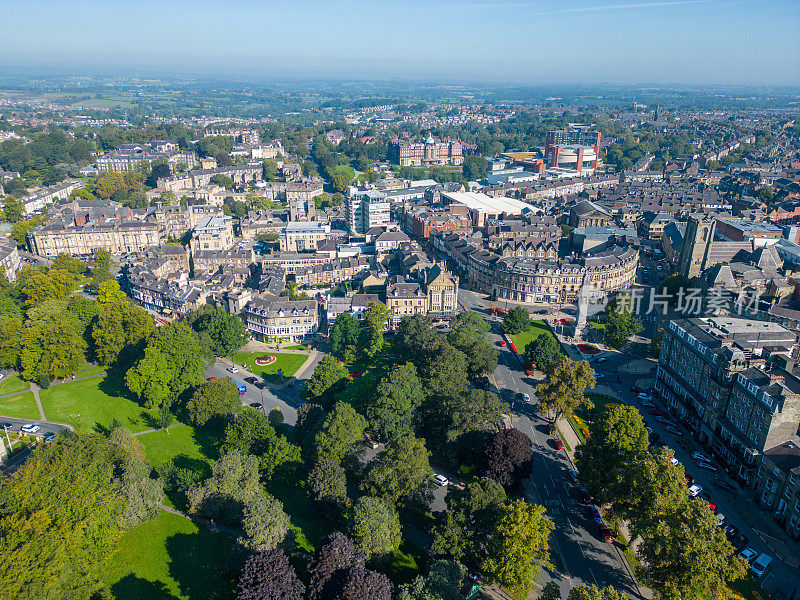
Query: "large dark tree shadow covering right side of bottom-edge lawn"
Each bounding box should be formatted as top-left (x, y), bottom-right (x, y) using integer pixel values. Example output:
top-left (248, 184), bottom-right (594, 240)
top-left (164, 528), bottom-right (236, 600)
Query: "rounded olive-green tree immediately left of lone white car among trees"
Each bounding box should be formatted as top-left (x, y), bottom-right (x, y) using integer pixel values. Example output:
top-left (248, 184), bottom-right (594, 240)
top-left (361, 435), bottom-right (433, 506)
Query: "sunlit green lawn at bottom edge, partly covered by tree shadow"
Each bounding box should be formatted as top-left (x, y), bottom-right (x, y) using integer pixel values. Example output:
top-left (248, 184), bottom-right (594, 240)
top-left (105, 512), bottom-right (235, 600)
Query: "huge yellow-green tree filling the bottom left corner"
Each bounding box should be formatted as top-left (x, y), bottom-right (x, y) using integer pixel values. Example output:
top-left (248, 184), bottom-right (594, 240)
top-left (0, 434), bottom-right (124, 600)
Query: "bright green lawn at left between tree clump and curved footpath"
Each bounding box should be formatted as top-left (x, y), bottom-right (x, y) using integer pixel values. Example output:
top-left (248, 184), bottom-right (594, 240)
top-left (39, 373), bottom-right (156, 433)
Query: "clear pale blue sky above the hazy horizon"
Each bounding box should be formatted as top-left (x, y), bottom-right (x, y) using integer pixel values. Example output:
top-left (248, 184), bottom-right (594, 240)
top-left (0, 0), bottom-right (800, 85)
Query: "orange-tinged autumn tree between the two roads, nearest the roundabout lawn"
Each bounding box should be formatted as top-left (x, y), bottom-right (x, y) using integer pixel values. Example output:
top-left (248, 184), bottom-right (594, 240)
top-left (536, 356), bottom-right (597, 423)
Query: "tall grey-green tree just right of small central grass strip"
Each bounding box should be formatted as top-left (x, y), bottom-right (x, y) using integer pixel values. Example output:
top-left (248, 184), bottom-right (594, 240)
top-left (367, 363), bottom-right (425, 440)
